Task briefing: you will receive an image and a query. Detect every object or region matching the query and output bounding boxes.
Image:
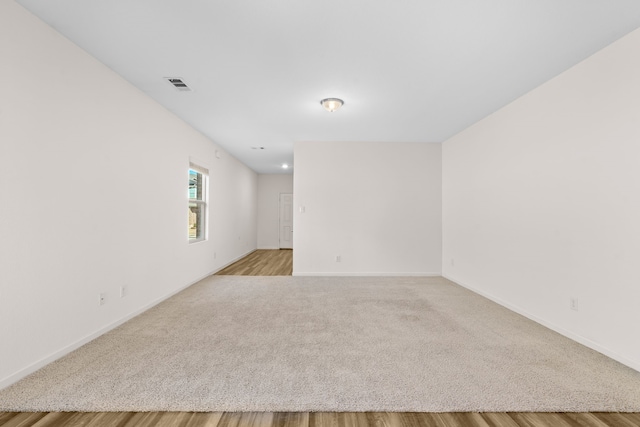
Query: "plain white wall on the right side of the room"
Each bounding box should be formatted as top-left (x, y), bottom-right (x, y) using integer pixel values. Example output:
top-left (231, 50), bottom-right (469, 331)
top-left (443, 31), bottom-right (640, 370)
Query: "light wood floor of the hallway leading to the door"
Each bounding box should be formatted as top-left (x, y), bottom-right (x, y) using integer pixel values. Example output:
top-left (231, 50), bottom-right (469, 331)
top-left (216, 249), bottom-right (293, 276)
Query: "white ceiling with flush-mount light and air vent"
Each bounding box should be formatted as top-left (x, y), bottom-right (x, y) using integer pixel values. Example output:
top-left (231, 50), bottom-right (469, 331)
top-left (17, 0), bottom-right (640, 173)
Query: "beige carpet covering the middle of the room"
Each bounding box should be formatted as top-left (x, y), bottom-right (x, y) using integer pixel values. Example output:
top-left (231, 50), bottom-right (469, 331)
top-left (0, 276), bottom-right (640, 412)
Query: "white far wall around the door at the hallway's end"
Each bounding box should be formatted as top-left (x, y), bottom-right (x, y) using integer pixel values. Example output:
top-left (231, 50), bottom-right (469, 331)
top-left (258, 174), bottom-right (295, 249)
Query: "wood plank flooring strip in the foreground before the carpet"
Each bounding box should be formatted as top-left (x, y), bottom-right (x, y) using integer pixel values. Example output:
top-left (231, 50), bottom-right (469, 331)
top-left (0, 412), bottom-right (640, 427)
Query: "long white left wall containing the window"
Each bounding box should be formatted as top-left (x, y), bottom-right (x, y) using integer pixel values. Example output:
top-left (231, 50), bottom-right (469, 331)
top-left (0, 0), bottom-right (257, 387)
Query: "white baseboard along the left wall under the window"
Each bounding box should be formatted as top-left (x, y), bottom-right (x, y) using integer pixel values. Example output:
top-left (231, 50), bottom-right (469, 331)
top-left (0, 270), bottom-right (224, 390)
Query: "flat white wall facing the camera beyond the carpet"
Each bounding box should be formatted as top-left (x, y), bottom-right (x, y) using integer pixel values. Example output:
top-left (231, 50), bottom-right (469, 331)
top-left (293, 142), bottom-right (441, 275)
